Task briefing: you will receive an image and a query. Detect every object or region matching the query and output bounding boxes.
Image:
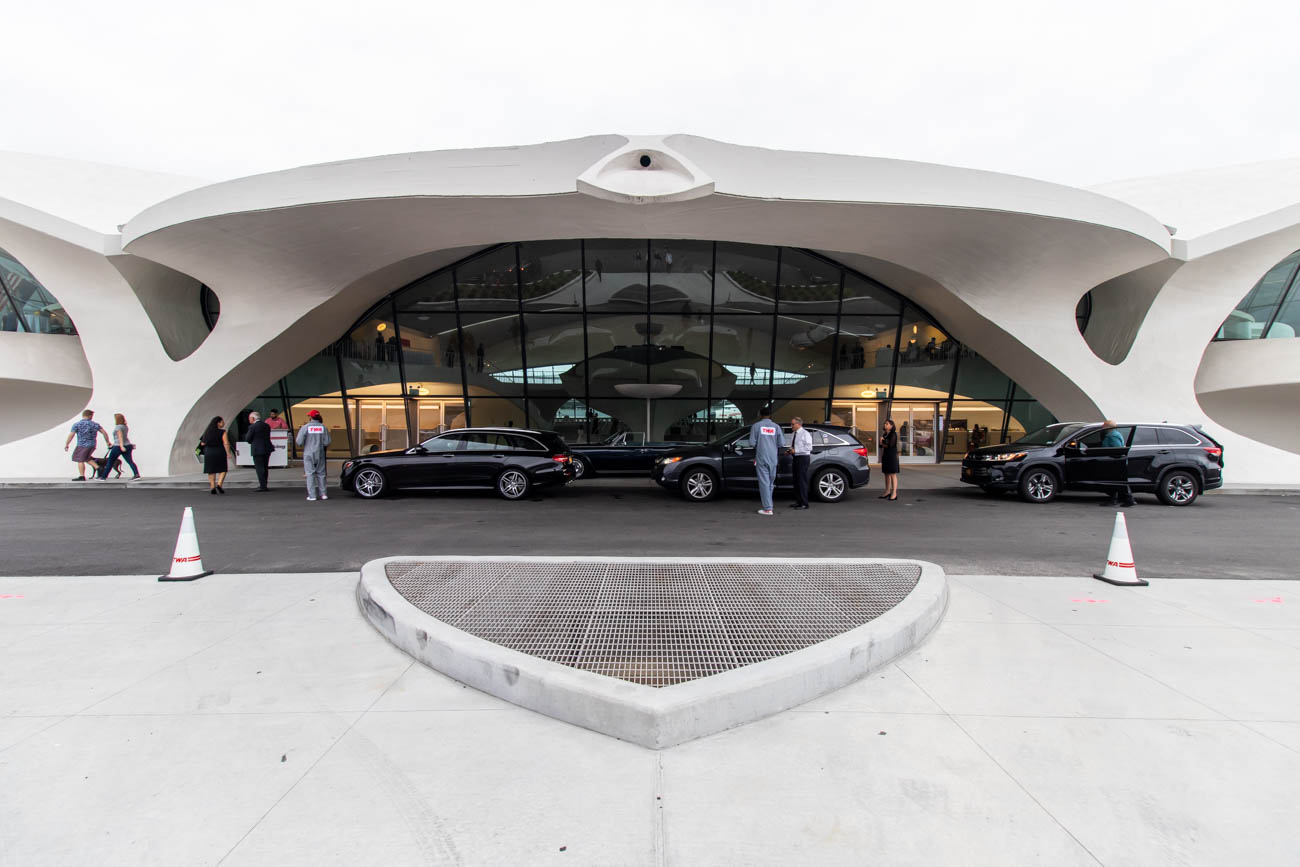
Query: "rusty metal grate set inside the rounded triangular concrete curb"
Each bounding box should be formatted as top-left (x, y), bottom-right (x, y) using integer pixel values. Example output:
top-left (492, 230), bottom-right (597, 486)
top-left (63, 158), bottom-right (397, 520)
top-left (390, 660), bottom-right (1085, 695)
top-left (386, 560), bottom-right (920, 686)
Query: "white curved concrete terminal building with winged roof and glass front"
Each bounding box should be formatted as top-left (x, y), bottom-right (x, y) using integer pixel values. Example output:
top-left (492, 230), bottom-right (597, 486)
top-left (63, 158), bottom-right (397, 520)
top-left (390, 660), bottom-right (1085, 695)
top-left (0, 135), bottom-right (1300, 485)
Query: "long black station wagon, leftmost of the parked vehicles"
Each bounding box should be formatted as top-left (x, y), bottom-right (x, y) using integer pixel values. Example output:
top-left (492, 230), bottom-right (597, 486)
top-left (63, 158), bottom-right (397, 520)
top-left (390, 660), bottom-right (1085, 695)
top-left (341, 428), bottom-right (573, 499)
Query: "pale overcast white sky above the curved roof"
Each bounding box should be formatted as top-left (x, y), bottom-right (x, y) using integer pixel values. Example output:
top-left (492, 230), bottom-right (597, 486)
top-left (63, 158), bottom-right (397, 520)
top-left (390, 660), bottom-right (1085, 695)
top-left (0, 0), bottom-right (1300, 185)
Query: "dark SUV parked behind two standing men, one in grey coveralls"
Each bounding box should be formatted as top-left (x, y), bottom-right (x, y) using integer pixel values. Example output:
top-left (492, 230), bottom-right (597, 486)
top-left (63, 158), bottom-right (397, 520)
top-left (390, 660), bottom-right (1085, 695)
top-left (650, 425), bottom-right (871, 503)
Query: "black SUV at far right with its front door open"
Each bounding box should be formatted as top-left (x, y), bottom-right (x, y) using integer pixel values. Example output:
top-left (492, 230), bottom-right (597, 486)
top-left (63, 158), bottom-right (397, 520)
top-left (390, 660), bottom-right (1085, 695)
top-left (962, 422), bottom-right (1223, 506)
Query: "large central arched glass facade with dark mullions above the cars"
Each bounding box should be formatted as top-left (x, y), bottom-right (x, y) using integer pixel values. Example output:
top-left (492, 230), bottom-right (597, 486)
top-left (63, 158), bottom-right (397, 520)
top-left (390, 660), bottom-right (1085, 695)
top-left (250, 239), bottom-right (1052, 461)
